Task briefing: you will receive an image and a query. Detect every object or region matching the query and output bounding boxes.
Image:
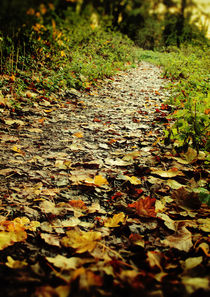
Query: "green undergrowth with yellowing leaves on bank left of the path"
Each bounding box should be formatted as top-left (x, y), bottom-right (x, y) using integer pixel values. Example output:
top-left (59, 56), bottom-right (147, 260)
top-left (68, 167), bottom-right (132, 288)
top-left (0, 10), bottom-right (135, 108)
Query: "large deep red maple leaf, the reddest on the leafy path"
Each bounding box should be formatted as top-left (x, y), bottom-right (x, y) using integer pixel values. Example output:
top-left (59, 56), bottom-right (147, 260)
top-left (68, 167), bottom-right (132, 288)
top-left (128, 197), bottom-right (156, 217)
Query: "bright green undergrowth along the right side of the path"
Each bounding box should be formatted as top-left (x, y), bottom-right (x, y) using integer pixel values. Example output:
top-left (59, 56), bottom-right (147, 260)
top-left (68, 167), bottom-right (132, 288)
top-left (138, 44), bottom-right (210, 152)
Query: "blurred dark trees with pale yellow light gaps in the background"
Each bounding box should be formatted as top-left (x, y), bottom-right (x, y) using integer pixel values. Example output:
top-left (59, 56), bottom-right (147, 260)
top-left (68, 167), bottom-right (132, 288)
top-left (0, 0), bottom-right (209, 49)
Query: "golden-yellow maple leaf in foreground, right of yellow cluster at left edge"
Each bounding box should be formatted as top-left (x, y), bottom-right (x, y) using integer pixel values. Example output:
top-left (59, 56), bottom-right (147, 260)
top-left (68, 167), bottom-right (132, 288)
top-left (61, 230), bottom-right (101, 253)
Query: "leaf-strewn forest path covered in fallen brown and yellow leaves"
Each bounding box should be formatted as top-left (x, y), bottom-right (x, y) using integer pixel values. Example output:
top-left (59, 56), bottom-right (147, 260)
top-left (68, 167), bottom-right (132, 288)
top-left (0, 62), bottom-right (210, 297)
